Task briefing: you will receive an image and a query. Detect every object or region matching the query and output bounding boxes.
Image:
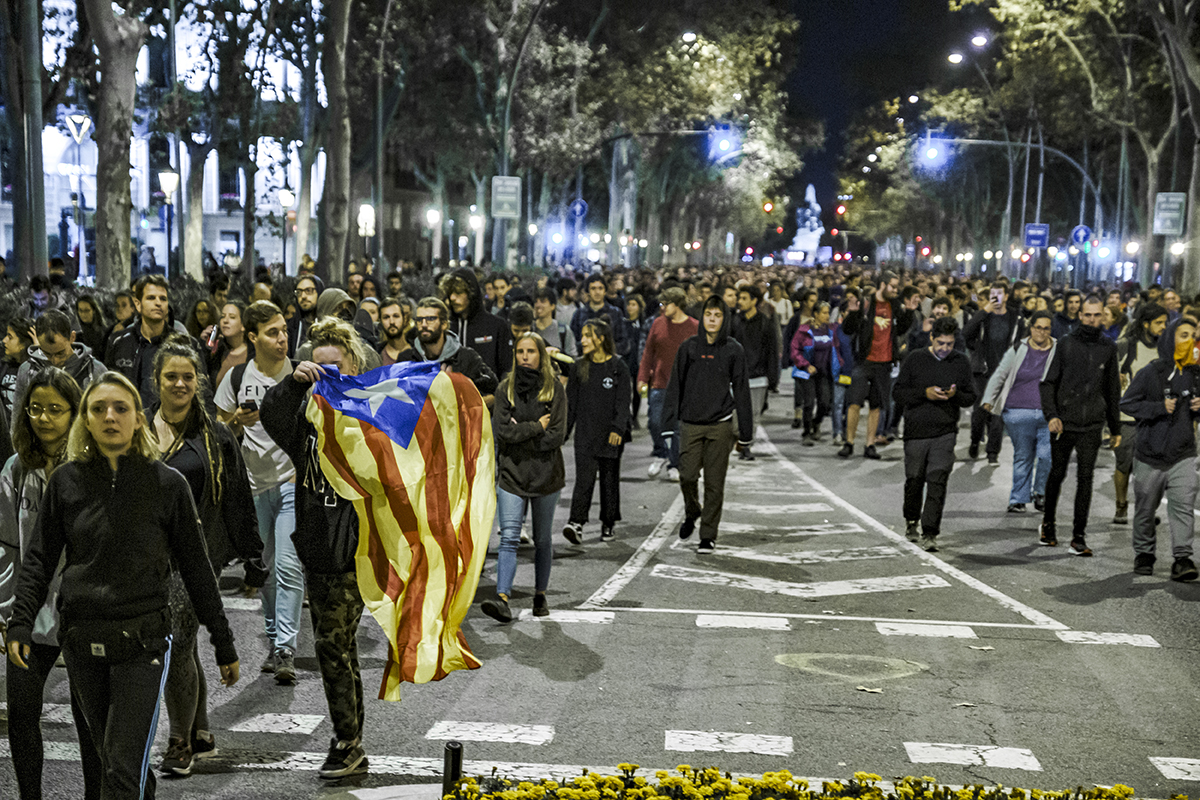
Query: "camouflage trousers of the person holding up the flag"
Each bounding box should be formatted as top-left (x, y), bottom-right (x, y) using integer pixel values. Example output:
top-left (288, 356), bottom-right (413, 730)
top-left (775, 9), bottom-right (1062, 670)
top-left (305, 571), bottom-right (364, 741)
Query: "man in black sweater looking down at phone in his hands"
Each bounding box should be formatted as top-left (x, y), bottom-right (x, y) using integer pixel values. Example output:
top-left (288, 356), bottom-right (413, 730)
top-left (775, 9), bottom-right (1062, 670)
top-left (894, 317), bottom-right (976, 553)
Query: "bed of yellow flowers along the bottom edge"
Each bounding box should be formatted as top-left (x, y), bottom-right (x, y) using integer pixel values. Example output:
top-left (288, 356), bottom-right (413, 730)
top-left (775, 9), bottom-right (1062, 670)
top-left (444, 764), bottom-right (1188, 800)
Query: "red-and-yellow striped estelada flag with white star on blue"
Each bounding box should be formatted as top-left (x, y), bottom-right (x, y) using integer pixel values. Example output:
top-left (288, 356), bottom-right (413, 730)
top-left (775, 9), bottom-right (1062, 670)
top-left (306, 362), bottom-right (496, 700)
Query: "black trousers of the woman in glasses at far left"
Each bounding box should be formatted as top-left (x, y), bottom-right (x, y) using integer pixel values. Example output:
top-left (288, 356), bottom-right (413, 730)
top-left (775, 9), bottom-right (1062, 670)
top-left (5, 643), bottom-right (103, 800)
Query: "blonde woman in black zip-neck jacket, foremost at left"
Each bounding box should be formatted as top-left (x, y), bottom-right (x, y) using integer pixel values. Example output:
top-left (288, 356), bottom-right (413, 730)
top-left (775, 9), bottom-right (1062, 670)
top-left (7, 372), bottom-right (238, 798)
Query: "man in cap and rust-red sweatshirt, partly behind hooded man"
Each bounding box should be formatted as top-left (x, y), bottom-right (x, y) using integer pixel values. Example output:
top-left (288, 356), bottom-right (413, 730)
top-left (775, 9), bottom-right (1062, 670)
top-left (637, 287), bottom-right (700, 481)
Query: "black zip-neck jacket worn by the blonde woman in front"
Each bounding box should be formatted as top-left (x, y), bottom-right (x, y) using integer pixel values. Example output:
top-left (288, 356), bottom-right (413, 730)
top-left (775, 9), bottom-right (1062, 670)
top-left (8, 455), bottom-right (238, 664)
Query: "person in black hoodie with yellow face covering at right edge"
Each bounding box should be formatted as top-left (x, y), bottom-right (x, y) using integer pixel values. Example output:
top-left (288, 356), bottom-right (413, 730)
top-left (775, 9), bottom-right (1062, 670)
top-left (1121, 317), bottom-right (1200, 581)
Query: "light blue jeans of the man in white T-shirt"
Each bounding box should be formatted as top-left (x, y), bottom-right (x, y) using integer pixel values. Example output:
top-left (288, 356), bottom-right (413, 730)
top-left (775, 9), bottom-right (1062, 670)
top-left (254, 483), bottom-right (304, 652)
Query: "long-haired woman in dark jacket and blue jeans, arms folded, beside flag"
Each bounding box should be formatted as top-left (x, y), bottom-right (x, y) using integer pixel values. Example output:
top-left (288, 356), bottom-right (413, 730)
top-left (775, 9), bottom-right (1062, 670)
top-left (481, 333), bottom-right (566, 622)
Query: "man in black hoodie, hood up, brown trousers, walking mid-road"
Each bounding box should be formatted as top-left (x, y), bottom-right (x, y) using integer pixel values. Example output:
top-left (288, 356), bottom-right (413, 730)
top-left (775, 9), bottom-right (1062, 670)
top-left (662, 295), bottom-right (754, 553)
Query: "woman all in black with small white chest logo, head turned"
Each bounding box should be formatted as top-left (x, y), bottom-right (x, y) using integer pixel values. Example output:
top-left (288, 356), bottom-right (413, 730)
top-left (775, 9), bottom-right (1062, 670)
top-left (563, 317), bottom-right (630, 545)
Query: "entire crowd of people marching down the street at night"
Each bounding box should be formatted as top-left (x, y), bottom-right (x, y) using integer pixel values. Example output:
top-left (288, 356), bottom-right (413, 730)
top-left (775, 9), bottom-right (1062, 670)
top-left (0, 260), bottom-right (1200, 799)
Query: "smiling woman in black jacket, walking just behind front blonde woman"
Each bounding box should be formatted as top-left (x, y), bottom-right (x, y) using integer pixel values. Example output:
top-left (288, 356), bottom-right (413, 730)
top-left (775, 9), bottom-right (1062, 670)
top-left (150, 336), bottom-right (266, 775)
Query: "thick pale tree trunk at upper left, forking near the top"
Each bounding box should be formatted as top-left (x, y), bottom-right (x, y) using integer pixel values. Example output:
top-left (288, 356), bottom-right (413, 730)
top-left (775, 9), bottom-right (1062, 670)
top-left (84, 0), bottom-right (148, 288)
